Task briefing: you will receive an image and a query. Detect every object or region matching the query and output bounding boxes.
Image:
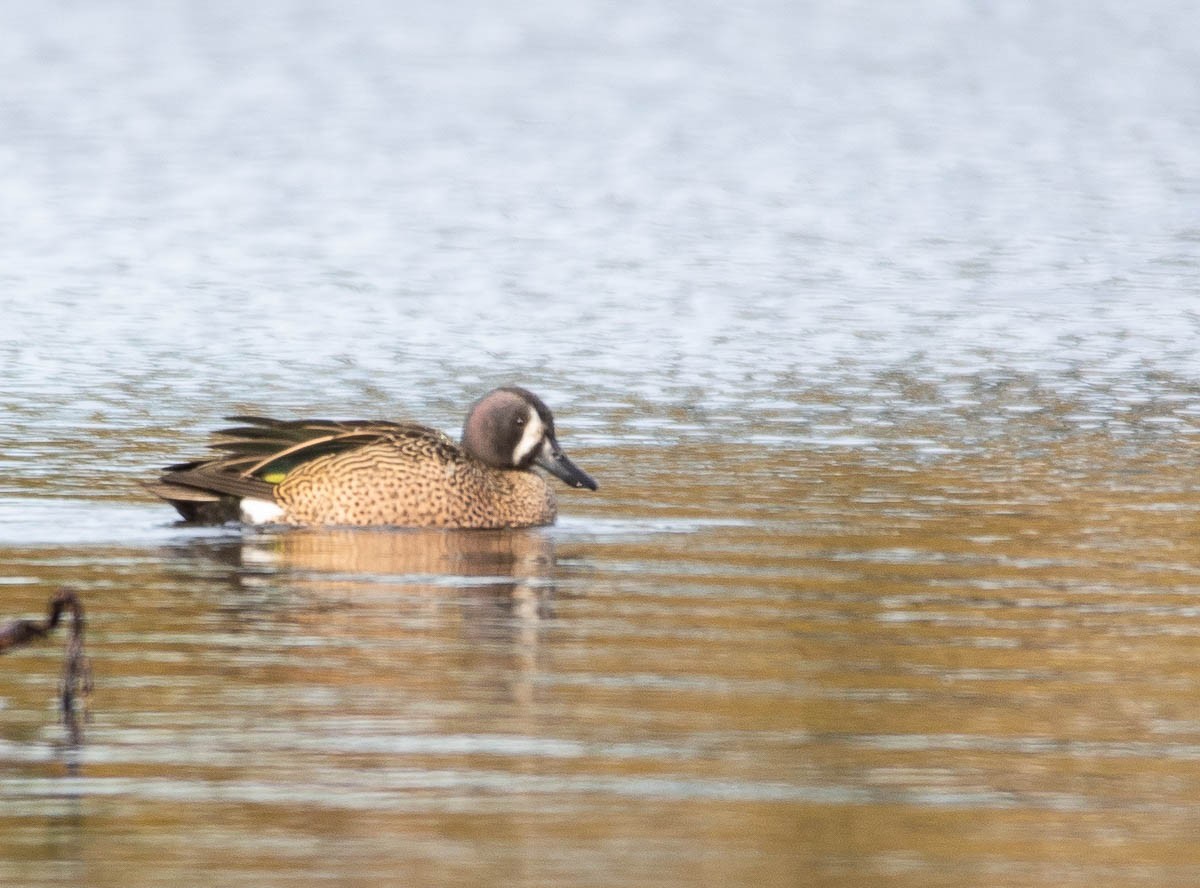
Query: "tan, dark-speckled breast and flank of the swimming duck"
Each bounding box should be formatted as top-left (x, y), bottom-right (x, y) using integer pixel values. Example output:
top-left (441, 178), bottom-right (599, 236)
top-left (275, 434), bottom-right (557, 528)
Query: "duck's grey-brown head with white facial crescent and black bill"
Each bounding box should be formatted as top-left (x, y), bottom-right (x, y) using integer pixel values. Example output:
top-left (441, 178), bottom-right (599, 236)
top-left (462, 385), bottom-right (599, 491)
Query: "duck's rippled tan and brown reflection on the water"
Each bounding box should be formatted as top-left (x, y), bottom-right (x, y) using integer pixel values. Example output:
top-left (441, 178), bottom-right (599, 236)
top-left (165, 528), bottom-right (556, 700)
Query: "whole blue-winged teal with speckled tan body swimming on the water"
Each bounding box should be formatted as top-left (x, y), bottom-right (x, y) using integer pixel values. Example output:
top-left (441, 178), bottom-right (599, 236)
top-left (148, 386), bottom-right (596, 528)
